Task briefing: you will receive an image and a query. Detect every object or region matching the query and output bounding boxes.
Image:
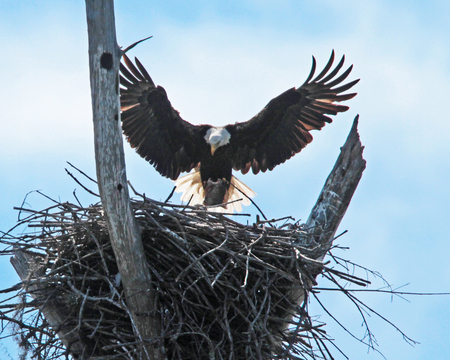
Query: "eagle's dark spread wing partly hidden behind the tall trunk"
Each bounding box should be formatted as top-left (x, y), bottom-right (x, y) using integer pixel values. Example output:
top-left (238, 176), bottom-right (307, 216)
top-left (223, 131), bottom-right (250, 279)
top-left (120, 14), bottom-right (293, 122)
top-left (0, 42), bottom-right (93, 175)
top-left (120, 55), bottom-right (208, 180)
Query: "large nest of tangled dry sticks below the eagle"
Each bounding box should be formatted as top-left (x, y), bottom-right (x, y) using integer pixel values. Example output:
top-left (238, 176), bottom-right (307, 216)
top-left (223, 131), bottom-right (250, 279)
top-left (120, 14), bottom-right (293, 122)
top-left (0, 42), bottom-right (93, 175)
top-left (3, 195), bottom-right (366, 359)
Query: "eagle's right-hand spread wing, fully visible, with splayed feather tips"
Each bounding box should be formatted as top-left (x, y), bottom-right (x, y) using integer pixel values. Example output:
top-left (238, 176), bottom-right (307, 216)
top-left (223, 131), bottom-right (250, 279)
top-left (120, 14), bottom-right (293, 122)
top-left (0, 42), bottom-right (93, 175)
top-left (226, 51), bottom-right (359, 174)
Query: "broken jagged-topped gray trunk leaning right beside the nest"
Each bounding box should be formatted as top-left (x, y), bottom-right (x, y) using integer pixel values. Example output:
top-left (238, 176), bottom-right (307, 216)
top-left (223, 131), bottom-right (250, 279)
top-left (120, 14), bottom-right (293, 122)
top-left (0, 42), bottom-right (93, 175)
top-left (306, 115), bottom-right (366, 261)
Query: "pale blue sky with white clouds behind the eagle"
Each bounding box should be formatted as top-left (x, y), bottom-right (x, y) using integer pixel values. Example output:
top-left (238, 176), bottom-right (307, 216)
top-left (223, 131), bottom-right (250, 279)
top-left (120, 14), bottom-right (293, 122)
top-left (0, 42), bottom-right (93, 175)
top-left (0, 0), bottom-right (450, 360)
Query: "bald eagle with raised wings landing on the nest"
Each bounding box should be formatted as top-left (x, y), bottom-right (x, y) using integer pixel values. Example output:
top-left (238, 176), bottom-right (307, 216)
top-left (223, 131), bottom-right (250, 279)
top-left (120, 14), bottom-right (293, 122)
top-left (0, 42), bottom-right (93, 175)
top-left (120, 51), bottom-right (359, 211)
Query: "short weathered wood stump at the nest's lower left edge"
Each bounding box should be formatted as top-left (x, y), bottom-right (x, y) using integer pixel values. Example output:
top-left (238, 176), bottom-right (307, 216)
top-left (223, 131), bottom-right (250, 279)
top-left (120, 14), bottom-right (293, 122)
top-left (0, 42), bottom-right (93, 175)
top-left (10, 250), bottom-right (89, 359)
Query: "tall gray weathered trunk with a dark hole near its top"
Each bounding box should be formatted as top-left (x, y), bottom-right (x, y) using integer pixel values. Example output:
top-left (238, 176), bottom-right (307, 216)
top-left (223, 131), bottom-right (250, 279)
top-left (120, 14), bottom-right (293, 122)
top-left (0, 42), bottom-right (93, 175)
top-left (86, 0), bottom-right (160, 359)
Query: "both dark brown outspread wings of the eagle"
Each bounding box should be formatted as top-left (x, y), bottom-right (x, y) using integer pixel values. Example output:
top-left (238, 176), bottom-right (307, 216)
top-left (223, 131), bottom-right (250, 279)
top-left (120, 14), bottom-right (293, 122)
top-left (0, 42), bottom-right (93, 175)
top-left (120, 51), bottom-right (359, 179)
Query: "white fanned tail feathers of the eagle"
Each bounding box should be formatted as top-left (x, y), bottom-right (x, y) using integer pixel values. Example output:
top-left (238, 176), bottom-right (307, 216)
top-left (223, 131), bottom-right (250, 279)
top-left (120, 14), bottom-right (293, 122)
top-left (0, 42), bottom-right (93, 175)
top-left (175, 168), bottom-right (256, 213)
